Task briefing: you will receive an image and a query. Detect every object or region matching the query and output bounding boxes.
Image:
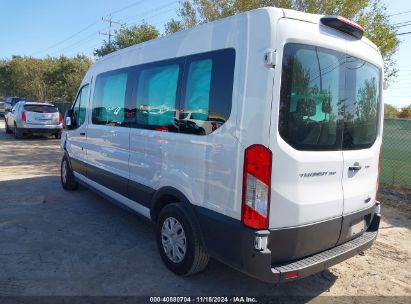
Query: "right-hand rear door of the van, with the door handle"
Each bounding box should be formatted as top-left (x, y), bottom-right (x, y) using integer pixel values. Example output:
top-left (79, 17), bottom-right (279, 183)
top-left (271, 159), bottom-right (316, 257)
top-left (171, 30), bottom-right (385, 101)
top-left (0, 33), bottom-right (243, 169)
top-left (339, 40), bottom-right (383, 243)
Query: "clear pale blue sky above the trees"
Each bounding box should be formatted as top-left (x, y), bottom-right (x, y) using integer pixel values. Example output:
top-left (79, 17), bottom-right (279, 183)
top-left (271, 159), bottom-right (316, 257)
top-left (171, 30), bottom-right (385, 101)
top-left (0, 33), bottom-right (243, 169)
top-left (0, 0), bottom-right (411, 108)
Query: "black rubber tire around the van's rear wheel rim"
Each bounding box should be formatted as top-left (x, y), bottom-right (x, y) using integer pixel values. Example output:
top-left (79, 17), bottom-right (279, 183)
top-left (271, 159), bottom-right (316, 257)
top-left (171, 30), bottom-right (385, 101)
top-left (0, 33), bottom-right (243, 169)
top-left (156, 203), bottom-right (210, 276)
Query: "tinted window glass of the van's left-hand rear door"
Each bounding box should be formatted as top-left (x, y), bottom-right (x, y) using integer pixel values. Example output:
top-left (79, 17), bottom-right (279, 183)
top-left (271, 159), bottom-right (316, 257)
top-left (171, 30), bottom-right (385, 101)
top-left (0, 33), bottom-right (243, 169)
top-left (279, 44), bottom-right (345, 150)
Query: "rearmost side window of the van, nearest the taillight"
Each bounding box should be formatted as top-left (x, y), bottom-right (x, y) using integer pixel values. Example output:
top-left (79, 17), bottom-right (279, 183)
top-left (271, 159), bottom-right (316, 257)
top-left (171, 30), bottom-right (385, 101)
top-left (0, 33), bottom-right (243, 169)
top-left (179, 49), bottom-right (235, 135)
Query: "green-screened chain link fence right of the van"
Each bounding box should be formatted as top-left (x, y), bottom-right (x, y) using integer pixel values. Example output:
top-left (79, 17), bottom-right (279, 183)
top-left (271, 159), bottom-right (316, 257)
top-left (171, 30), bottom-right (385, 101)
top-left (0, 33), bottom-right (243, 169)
top-left (380, 119), bottom-right (411, 189)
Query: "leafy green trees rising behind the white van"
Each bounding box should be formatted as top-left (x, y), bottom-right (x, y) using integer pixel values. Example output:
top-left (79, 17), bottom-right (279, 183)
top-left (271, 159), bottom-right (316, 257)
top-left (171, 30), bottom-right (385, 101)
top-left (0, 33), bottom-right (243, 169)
top-left (0, 0), bottom-right (406, 105)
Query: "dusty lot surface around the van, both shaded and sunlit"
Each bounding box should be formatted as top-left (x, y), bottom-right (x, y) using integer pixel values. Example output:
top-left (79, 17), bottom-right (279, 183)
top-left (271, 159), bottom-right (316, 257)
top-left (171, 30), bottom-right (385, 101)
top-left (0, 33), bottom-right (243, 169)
top-left (0, 121), bottom-right (411, 303)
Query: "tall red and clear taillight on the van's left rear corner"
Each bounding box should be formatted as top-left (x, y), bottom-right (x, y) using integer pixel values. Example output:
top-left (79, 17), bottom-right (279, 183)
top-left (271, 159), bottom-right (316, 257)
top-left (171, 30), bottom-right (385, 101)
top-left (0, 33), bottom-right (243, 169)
top-left (241, 145), bottom-right (272, 229)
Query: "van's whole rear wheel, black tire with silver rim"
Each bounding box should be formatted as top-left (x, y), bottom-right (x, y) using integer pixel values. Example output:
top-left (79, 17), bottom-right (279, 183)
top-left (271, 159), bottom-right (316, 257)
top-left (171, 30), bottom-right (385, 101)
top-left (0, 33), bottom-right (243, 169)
top-left (156, 203), bottom-right (210, 276)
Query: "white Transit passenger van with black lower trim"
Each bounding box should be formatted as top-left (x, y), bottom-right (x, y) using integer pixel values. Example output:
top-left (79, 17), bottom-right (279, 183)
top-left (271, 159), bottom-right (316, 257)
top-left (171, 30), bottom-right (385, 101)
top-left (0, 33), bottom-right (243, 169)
top-left (61, 8), bottom-right (383, 282)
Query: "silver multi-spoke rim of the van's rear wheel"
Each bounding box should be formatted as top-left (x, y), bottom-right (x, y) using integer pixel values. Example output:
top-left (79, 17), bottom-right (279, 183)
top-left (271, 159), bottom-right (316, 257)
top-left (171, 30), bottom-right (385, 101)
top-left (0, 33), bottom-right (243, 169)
top-left (161, 217), bottom-right (187, 263)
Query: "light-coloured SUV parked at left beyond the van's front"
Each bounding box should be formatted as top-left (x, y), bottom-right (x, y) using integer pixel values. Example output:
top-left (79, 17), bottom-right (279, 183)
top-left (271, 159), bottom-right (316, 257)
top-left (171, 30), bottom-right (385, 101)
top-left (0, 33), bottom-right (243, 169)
top-left (4, 101), bottom-right (63, 138)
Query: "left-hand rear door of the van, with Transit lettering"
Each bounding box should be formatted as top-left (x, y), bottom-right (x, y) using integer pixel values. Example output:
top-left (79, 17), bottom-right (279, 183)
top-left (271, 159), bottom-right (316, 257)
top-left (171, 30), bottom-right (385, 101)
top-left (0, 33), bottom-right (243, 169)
top-left (269, 18), bottom-right (346, 230)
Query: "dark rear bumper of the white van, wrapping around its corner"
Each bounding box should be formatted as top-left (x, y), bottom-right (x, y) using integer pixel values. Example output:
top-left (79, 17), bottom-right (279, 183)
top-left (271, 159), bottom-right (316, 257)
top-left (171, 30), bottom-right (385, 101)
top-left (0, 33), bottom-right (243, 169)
top-left (196, 203), bottom-right (380, 283)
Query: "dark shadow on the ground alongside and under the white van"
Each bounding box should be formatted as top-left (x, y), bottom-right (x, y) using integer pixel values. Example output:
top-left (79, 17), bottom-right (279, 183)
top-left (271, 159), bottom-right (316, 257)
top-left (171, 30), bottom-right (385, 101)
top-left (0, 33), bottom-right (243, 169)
top-left (0, 176), bottom-right (337, 298)
